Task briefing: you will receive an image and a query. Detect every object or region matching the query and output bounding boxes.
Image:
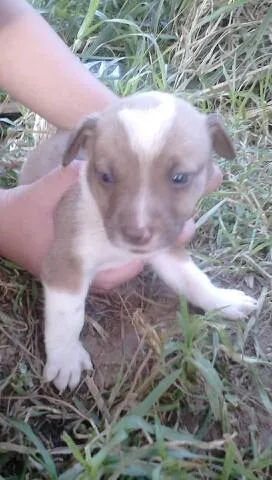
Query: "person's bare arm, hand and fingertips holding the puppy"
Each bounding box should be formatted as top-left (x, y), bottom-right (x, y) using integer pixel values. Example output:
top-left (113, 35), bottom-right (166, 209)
top-left (0, 0), bottom-right (222, 291)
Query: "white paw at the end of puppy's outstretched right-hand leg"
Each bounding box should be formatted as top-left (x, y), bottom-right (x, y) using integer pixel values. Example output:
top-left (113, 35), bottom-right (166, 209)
top-left (211, 288), bottom-right (258, 320)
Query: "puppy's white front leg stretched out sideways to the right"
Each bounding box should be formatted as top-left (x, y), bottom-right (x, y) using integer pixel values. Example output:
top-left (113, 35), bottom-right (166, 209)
top-left (151, 249), bottom-right (257, 319)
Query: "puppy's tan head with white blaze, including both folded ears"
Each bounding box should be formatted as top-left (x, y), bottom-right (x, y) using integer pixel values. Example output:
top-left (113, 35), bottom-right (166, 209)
top-left (63, 92), bottom-right (235, 253)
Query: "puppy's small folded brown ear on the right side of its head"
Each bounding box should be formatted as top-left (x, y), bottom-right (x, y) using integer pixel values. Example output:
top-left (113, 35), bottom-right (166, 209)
top-left (207, 113), bottom-right (236, 160)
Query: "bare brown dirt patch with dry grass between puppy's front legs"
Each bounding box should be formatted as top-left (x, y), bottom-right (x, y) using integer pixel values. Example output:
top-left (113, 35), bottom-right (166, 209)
top-left (82, 270), bottom-right (181, 388)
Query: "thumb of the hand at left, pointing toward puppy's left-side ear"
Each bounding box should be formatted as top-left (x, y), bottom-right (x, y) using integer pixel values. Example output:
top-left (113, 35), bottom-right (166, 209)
top-left (32, 160), bottom-right (82, 207)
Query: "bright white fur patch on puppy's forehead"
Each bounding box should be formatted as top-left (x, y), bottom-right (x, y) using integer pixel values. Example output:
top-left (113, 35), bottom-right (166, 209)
top-left (118, 92), bottom-right (176, 159)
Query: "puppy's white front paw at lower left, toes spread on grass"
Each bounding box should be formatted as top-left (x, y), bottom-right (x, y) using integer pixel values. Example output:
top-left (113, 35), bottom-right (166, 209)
top-left (44, 340), bottom-right (93, 392)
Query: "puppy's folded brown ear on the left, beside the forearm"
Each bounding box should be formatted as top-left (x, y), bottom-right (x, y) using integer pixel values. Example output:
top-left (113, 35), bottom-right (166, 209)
top-left (62, 117), bottom-right (98, 167)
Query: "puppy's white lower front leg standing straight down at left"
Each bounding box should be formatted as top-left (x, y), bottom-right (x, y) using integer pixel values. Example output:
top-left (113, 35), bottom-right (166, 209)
top-left (44, 281), bottom-right (92, 391)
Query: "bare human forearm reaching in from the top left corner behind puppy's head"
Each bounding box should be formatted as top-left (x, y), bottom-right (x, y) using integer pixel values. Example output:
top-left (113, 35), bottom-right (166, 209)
top-left (0, 0), bottom-right (115, 128)
